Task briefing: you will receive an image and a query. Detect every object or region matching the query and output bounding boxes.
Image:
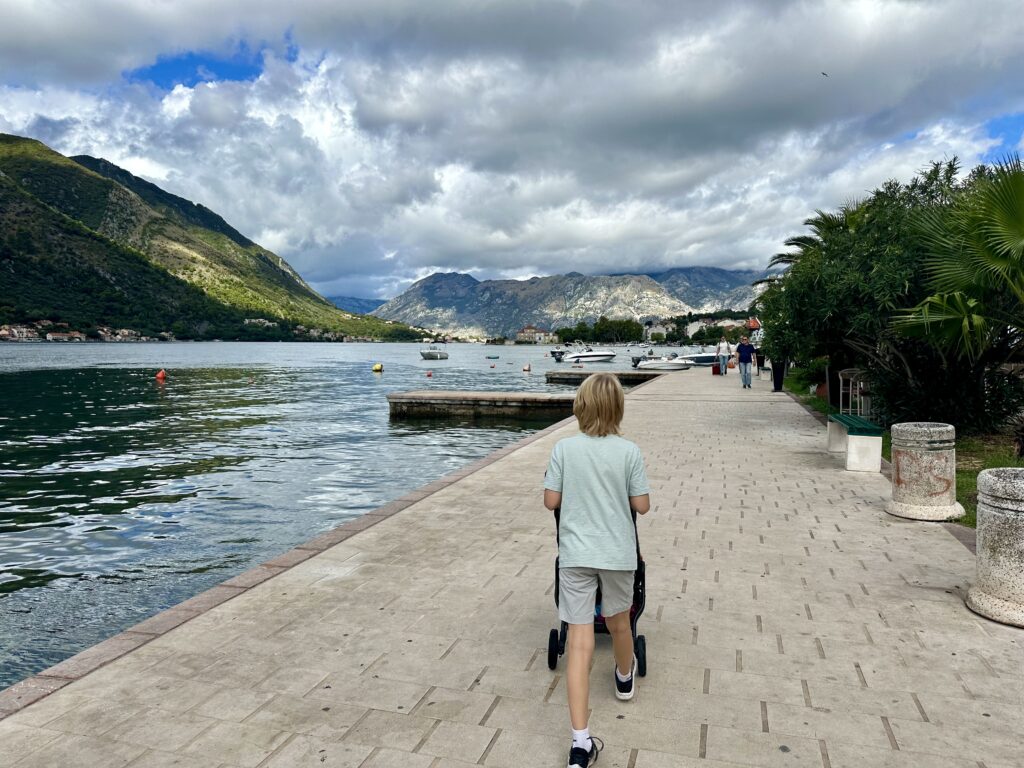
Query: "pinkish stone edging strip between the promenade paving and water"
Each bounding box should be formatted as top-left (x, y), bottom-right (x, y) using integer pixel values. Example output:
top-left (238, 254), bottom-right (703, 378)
top-left (0, 379), bottom-right (656, 720)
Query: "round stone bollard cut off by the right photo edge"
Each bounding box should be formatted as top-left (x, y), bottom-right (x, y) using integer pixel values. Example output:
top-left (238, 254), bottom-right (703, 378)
top-left (967, 468), bottom-right (1024, 627)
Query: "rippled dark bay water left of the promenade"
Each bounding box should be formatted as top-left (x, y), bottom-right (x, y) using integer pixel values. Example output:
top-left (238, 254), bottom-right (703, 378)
top-left (0, 343), bottom-right (629, 688)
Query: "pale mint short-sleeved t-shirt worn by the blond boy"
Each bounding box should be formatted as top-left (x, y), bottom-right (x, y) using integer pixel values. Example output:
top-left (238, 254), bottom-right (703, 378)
top-left (544, 432), bottom-right (650, 570)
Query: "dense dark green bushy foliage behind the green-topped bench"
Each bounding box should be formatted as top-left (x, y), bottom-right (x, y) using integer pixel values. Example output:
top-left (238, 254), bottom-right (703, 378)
top-left (756, 160), bottom-right (1024, 431)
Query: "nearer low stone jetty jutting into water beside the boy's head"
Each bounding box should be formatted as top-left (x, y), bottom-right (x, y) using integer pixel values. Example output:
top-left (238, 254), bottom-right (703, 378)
top-left (387, 389), bottom-right (574, 421)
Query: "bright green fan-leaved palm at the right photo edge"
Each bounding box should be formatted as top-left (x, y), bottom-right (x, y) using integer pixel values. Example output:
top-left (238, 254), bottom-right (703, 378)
top-left (894, 158), bottom-right (1024, 362)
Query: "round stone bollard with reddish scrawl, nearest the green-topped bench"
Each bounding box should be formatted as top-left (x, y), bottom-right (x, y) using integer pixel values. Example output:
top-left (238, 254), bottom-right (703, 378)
top-left (886, 421), bottom-right (964, 520)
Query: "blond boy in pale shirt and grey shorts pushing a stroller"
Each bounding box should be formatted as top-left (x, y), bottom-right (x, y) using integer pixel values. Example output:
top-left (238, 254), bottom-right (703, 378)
top-left (544, 373), bottom-right (650, 768)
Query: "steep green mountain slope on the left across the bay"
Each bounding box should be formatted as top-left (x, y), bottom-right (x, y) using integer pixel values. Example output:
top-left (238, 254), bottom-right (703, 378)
top-left (0, 134), bottom-right (417, 338)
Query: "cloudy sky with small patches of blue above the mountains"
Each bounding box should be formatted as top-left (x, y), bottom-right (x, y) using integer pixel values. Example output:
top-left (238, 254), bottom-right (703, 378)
top-left (0, 0), bottom-right (1024, 298)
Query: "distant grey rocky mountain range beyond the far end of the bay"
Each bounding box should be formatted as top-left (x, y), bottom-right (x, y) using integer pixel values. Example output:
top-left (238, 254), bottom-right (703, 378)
top-left (373, 266), bottom-right (765, 336)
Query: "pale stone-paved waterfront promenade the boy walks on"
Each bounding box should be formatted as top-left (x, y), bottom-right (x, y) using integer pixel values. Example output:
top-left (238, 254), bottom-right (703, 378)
top-left (0, 369), bottom-right (1024, 768)
